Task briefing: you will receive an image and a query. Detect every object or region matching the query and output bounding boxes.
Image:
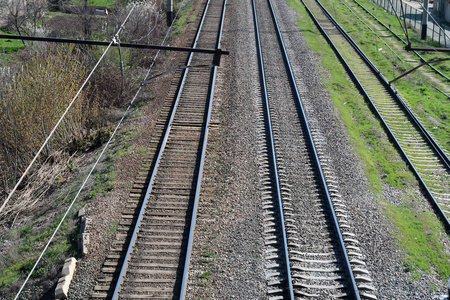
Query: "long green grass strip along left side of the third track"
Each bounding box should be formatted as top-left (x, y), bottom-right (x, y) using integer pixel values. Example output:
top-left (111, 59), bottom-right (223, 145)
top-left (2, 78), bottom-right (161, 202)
top-left (288, 0), bottom-right (414, 191)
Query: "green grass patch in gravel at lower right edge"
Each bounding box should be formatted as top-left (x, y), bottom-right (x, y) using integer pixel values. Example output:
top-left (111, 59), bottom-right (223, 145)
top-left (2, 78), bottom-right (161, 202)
top-left (385, 200), bottom-right (450, 279)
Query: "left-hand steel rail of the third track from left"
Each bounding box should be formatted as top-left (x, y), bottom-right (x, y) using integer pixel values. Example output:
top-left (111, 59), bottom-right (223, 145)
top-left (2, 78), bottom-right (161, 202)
top-left (301, 0), bottom-right (450, 229)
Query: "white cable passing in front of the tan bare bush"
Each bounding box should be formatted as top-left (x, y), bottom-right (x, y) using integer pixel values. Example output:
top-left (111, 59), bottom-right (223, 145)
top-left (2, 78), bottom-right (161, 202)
top-left (0, 6), bottom-right (135, 214)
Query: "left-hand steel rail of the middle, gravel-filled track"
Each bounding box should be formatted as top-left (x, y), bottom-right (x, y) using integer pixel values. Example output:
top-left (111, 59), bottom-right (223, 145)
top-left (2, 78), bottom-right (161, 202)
top-left (252, 0), bottom-right (295, 300)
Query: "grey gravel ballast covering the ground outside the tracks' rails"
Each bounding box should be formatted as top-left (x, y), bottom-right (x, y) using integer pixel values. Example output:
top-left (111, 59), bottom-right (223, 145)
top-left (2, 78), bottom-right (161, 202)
top-left (69, 0), bottom-right (449, 299)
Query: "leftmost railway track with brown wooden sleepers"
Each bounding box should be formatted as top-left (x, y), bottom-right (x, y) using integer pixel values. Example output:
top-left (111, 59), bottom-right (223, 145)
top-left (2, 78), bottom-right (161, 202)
top-left (92, 0), bottom-right (226, 299)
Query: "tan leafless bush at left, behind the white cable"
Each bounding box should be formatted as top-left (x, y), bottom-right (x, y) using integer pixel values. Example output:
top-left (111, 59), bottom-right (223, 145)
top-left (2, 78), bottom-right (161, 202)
top-left (0, 47), bottom-right (98, 195)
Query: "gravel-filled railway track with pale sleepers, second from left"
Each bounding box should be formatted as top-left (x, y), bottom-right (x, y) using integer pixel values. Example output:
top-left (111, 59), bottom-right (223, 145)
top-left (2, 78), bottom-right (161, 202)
top-left (253, 0), bottom-right (376, 299)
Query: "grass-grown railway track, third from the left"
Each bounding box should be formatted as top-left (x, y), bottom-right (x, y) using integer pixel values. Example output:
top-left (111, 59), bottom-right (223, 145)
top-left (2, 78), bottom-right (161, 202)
top-left (302, 0), bottom-right (450, 227)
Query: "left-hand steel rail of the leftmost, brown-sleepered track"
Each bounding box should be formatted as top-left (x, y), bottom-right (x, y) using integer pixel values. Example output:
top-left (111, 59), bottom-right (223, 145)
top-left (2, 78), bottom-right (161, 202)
top-left (112, 0), bottom-right (214, 300)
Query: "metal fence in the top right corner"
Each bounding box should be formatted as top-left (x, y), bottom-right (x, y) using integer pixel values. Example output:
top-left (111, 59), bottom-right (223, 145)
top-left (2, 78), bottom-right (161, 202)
top-left (371, 0), bottom-right (450, 47)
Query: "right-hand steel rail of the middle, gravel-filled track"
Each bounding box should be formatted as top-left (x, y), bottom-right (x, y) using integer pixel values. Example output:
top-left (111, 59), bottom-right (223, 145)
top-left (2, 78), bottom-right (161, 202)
top-left (267, 0), bottom-right (360, 299)
